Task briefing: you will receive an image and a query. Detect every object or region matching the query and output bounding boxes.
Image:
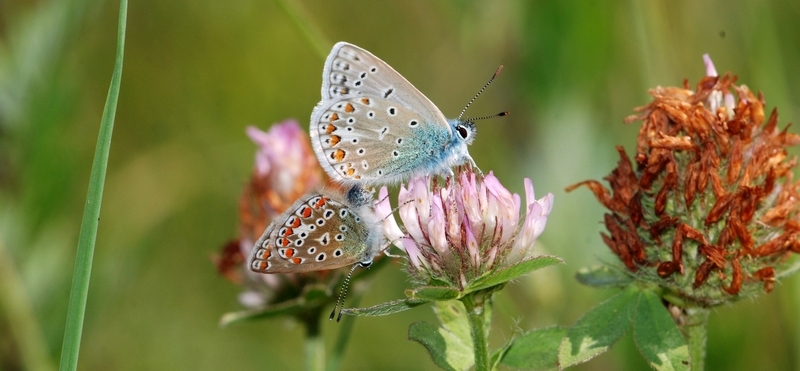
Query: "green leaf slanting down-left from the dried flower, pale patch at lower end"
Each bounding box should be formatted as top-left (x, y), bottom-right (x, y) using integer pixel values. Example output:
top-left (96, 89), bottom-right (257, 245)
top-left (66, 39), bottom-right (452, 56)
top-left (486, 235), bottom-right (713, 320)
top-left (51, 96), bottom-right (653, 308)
top-left (558, 286), bottom-right (641, 368)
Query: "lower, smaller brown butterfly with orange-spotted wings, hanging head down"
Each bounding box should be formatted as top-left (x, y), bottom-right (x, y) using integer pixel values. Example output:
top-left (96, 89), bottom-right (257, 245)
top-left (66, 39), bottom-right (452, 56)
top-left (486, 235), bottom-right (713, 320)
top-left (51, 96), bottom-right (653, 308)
top-left (248, 190), bottom-right (384, 273)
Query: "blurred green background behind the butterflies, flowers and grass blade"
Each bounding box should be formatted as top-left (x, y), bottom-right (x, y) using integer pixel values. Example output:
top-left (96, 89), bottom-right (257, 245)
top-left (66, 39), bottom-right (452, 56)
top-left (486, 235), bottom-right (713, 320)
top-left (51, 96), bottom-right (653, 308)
top-left (0, 0), bottom-right (800, 370)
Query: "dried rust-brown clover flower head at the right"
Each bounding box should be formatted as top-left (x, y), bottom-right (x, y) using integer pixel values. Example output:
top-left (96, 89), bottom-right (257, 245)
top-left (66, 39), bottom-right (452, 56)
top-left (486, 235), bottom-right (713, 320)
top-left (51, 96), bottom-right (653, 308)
top-left (568, 56), bottom-right (800, 306)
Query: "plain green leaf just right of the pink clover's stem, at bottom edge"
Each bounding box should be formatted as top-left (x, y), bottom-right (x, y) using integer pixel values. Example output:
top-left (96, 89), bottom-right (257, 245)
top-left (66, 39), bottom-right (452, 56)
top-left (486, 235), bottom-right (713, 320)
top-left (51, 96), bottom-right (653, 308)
top-left (500, 327), bottom-right (568, 370)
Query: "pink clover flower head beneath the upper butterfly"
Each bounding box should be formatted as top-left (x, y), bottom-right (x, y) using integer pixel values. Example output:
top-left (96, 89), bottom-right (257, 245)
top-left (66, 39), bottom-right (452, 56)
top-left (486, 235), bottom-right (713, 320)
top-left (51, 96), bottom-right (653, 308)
top-left (376, 168), bottom-right (553, 290)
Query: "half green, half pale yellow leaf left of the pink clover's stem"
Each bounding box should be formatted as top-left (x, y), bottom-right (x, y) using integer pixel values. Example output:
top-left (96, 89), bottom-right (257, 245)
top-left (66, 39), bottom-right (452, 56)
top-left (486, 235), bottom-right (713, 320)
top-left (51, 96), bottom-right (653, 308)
top-left (408, 322), bottom-right (474, 371)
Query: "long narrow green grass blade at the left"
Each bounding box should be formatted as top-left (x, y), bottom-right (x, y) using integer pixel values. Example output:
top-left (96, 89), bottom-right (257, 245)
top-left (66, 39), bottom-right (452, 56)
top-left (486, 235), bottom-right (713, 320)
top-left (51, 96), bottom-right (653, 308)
top-left (59, 0), bottom-right (128, 371)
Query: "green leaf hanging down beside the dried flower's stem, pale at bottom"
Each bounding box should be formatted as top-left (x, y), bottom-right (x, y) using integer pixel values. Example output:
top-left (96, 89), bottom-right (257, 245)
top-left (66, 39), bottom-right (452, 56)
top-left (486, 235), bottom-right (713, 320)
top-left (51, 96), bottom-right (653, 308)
top-left (633, 290), bottom-right (689, 370)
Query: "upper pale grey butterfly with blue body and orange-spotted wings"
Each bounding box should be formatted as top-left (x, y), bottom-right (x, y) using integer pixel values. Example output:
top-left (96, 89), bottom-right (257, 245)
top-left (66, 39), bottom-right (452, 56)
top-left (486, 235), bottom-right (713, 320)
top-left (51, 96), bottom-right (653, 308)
top-left (310, 42), bottom-right (499, 186)
